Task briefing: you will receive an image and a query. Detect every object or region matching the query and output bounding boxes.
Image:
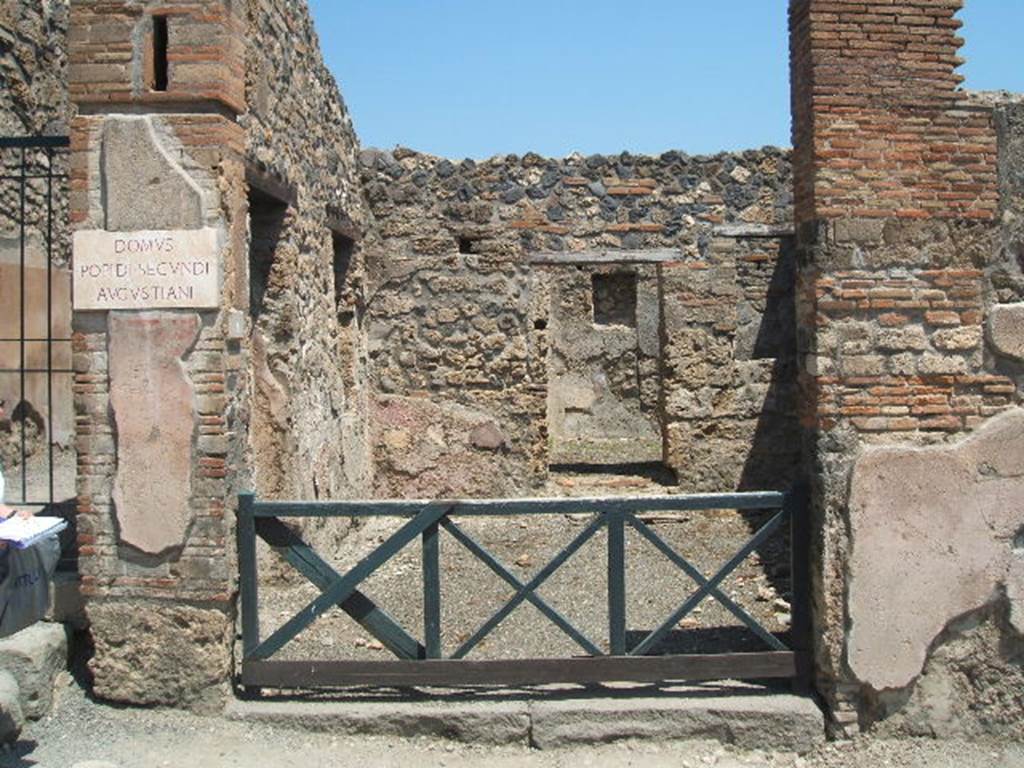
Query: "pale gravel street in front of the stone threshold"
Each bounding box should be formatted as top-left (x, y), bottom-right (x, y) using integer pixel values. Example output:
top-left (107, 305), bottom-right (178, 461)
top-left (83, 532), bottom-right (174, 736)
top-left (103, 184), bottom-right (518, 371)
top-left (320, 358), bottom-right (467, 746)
top-left (0, 681), bottom-right (1024, 768)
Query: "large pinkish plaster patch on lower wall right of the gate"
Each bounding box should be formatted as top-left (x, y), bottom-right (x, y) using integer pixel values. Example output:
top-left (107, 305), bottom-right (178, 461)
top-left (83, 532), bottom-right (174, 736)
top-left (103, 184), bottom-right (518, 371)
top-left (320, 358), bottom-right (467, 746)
top-left (848, 409), bottom-right (1024, 690)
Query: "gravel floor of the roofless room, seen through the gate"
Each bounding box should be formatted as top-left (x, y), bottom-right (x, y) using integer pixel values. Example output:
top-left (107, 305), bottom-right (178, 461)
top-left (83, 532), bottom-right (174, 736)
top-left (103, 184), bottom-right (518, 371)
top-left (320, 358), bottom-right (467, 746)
top-left (260, 475), bottom-right (791, 660)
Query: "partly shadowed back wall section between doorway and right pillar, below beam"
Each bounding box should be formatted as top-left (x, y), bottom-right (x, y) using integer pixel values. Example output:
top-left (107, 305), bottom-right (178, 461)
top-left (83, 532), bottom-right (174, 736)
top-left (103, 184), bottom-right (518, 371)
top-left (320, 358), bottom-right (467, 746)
top-left (663, 227), bottom-right (800, 493)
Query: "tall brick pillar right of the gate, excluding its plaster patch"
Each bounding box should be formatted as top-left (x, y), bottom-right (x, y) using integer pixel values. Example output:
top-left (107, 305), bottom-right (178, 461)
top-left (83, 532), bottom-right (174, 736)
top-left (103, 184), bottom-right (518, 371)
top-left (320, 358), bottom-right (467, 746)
top-left (790, 0), bottom-right (1014, 728)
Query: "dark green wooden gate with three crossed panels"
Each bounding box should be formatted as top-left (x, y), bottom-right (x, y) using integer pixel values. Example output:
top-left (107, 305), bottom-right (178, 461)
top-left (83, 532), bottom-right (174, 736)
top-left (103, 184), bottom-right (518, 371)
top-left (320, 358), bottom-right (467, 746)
top-left (238, 492), bottom-right (809, 688)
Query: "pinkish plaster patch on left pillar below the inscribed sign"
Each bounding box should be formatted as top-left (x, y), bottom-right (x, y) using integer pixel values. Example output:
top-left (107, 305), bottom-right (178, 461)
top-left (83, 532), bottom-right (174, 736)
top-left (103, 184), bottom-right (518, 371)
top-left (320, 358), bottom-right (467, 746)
top-left (110, 312), bottom-right (200, 554)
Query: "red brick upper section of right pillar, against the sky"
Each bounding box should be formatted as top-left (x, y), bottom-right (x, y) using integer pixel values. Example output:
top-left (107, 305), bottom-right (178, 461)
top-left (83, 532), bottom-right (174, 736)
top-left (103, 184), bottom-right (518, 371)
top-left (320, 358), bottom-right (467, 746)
top-left (791, 0), bottom-right (998, 221)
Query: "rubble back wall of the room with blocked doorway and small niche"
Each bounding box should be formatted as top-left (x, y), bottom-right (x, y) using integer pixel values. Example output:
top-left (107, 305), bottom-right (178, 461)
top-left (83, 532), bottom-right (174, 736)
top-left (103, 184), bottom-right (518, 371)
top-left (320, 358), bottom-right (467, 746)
top-left (361, 148), bottom-right (799, 497)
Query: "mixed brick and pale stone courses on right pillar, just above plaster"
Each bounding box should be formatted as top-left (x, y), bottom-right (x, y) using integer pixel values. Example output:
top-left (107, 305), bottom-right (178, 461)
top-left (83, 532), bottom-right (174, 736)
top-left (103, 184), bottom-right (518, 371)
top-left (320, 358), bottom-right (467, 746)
top-left (811, 269), bottom-right (1016, 433)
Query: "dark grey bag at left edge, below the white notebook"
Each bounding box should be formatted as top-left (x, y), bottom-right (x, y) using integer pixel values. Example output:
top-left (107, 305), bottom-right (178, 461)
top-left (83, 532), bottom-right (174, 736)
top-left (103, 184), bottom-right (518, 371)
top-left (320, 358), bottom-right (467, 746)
top-left (0, 536), bottom-right (60, 637)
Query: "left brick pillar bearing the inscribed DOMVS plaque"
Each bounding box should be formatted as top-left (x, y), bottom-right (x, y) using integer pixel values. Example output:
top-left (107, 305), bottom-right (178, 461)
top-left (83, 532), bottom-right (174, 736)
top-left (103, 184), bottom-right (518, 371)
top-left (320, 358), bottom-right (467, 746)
top-left (70, 0), bottom-right (248, 706)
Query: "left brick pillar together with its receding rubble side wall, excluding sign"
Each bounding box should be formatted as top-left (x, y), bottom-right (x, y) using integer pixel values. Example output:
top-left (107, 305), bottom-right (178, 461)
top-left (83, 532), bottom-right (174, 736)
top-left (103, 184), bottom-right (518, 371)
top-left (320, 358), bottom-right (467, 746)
top-left (70, 0), bottom-right (373, 707)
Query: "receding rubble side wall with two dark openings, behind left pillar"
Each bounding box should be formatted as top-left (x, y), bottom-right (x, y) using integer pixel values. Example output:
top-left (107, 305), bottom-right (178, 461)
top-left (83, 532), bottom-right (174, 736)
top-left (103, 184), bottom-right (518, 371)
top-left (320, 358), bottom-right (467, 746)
top-left (237, 0), bottom-right (373, 499)
